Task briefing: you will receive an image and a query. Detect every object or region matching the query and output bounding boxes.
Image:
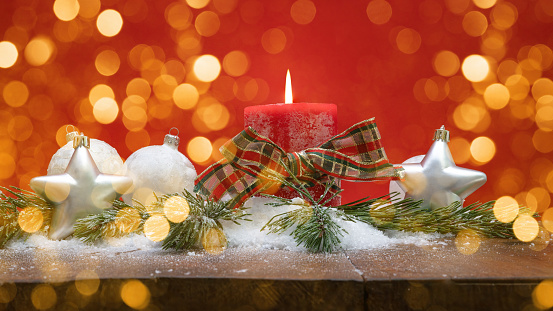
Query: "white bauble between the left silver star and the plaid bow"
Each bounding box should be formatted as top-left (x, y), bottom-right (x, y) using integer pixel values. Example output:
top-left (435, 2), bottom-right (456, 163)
top-left (123, 128), bottom-right (197, 204)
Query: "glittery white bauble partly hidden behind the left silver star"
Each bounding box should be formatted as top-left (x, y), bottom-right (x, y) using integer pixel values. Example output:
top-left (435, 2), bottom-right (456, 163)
top-left (47, 138), bottom-right (123, 175)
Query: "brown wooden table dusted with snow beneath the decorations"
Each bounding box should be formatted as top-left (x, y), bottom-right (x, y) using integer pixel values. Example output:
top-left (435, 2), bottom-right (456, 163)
top-left (0, 239), bottom-right (553, 310)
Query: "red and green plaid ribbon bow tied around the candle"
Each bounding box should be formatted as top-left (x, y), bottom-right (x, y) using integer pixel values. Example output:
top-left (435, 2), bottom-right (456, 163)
top-left (194, 118), bottom-right (401, 207)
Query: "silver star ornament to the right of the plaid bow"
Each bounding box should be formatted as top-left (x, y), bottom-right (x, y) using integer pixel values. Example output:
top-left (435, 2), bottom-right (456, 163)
top-left (390, 126), bottom-right (487, 210)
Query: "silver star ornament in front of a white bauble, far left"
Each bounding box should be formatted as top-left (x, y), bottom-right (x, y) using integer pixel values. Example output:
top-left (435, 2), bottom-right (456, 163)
top-left (30, 134), bottom-right (132, 240)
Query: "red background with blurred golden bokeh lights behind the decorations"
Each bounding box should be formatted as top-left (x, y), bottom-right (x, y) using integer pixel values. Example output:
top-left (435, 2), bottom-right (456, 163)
top-left (0, 0), bottom-right (553, 227)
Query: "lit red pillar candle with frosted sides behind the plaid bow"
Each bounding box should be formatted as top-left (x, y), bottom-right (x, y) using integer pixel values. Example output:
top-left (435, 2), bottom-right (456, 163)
top-left (244, 72), bottom-right (340, 205)
